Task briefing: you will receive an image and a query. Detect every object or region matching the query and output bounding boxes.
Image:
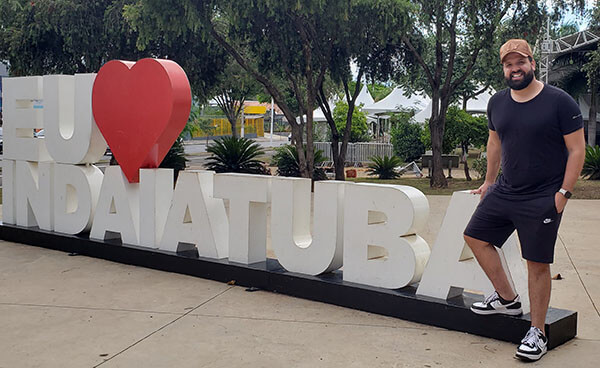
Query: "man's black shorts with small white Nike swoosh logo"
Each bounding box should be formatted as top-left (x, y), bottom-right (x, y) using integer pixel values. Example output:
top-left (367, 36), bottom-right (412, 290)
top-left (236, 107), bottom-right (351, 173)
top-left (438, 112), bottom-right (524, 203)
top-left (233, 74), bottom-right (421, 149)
top-left (464, 188), bottom-right (562, 263)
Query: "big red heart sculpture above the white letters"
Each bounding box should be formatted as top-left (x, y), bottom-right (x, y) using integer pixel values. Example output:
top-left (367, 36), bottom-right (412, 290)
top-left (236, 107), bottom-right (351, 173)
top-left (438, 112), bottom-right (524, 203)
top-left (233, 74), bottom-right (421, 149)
top-left (92, 59), bottom-right (192, 183)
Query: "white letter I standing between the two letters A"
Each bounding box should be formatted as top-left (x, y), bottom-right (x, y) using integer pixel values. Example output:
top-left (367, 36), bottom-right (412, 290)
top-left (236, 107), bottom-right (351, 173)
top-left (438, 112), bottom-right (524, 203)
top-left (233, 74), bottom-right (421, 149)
top-left (140, 169), bottom-right (176, 248)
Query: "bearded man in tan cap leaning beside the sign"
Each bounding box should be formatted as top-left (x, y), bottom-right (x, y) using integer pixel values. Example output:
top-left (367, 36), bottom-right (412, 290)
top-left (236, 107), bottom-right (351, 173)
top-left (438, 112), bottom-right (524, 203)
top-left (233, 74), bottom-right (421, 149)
top-left (464, 39), bottom-right (585, 360)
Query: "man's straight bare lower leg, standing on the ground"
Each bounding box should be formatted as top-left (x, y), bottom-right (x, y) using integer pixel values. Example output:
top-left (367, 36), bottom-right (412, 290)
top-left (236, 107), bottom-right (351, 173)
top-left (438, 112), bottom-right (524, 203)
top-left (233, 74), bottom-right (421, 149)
top-left (527, 261), bottom-right (552, 333)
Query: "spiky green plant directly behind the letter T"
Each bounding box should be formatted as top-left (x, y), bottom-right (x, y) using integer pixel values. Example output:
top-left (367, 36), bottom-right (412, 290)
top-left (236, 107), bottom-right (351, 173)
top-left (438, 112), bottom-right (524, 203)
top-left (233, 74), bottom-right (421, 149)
top-left (205, 137), bottom-right (267, 174)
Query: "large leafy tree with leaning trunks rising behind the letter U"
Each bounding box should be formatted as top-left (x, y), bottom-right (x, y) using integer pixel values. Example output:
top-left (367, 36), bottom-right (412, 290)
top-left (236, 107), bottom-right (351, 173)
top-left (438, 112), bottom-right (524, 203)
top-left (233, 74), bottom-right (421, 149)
top-left (127, 0), bottom-right (408, 180)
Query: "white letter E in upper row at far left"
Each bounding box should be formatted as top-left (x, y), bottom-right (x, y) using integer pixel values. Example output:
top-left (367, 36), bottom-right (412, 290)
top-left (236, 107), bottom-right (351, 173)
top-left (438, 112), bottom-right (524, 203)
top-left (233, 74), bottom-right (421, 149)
top-left (2, 77), bottom-right (51, 162)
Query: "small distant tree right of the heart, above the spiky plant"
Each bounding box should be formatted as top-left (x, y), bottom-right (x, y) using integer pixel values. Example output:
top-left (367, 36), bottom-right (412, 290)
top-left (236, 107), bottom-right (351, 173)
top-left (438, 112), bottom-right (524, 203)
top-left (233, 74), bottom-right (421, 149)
top-left (214, 60), bottom-right (261, 137)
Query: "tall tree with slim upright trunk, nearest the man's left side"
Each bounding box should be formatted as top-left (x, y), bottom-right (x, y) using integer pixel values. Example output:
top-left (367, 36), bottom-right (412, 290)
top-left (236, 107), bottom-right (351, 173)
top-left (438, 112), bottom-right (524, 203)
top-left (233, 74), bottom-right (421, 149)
top-left (399, 0), bottom-right (539, 187)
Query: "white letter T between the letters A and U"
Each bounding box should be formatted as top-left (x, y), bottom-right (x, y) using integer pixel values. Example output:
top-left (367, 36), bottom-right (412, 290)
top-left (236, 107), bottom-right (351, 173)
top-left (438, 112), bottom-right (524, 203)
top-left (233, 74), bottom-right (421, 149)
top-left (214, 173), bottom-right (271, 264)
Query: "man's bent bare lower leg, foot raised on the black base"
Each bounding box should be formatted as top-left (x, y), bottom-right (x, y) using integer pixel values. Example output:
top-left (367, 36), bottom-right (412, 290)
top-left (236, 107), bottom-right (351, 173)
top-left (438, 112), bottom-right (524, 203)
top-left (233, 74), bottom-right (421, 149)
top-left (464, 235), bottom-right (516, 302)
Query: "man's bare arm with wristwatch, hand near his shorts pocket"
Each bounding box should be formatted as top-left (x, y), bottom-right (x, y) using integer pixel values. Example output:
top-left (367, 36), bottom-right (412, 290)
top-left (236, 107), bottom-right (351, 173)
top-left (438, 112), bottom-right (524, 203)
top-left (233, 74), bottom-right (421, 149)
top-left (554, 128), bottom-right (585, 213)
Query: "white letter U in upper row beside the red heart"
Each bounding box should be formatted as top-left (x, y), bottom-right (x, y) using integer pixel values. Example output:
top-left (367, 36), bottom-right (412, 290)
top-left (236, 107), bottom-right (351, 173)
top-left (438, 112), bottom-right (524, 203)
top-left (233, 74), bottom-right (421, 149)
top-left (44, 74), bottom-right (106, 164)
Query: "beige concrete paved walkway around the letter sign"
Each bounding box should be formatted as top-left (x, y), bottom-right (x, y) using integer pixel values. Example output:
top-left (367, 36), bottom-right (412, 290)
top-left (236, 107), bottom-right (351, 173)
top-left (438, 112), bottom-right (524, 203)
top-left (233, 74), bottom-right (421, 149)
top-left (0, 196), bottom-right (600, 368)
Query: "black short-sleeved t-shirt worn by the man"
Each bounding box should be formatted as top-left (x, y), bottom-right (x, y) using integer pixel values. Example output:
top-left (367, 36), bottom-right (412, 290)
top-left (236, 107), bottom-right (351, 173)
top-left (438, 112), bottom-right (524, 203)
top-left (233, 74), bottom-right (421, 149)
top-left (488, 84), bottom-right (583, 198)
